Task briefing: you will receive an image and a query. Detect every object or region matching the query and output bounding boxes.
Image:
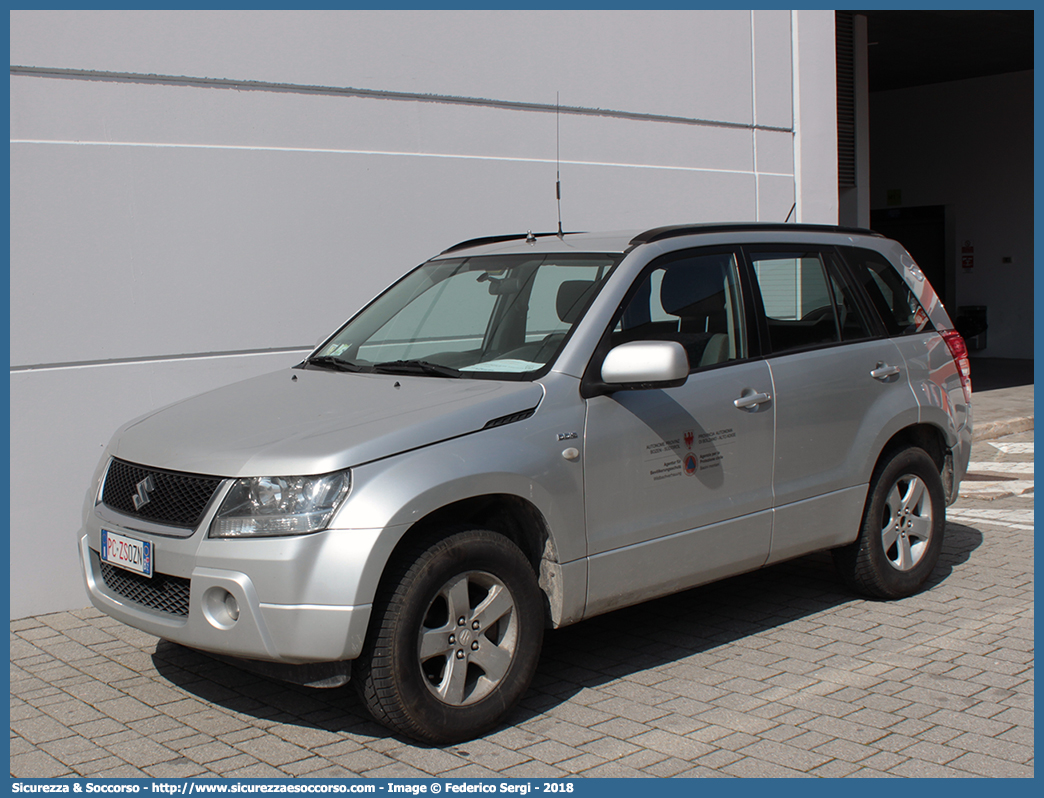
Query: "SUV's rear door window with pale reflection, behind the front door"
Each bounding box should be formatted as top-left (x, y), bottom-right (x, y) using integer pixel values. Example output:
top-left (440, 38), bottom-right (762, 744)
top-left (748, 249), bottom-right (873, 353)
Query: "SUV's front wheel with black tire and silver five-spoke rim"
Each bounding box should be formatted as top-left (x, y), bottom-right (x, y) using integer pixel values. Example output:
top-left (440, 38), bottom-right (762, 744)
top-left (354, 530), bottom-right (544, 745)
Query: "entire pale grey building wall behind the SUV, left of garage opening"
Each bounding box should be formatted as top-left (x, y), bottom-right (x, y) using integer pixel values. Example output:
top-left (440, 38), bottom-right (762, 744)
top-left (10, 11), bottom-right (836, 617)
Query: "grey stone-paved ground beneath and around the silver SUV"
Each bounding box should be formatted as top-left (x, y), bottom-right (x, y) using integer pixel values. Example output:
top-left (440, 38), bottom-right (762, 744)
top-left (10, 432), bottom-right (1034, 778)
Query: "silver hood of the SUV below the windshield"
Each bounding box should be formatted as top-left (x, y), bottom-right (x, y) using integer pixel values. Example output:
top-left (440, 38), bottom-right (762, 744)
top-left (110, 369), bottom-right (544, 477)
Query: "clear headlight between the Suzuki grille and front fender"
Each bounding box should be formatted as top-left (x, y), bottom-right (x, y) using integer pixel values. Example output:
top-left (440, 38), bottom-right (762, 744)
top-left (210, 471), bottom-right (352, 538)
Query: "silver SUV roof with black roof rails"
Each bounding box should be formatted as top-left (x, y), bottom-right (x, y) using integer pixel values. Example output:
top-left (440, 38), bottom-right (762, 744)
top-left (438, 221), bottom-right (882, 258)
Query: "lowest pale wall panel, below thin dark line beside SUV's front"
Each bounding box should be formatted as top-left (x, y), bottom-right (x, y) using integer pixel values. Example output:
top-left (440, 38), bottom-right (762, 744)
top-left (10, 352), bottom-right (301, 618)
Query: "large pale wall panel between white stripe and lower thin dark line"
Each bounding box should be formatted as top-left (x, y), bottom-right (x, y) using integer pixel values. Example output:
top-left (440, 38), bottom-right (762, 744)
top-left (10, 145), bottom-right (772, 366)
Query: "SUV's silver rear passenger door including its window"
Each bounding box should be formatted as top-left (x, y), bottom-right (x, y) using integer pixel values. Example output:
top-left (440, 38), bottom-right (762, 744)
top-left (744, 245), bottom-right (917, 562)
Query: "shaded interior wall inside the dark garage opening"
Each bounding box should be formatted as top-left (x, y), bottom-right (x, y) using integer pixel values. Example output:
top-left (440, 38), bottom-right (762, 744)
top-left (870, 72), bottom-right (1034, 359)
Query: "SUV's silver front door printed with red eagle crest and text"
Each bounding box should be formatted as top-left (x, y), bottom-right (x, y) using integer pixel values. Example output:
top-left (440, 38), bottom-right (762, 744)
top-left (584, 251), bottom-right (775, 615)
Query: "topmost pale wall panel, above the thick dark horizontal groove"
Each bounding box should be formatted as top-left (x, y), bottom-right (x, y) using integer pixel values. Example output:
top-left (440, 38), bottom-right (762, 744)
top-left (10, 10), bottom-right (751, 122)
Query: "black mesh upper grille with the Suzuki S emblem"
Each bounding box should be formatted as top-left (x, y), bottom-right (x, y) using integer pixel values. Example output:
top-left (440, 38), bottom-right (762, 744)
top-left (101, 460), bottom-right (221, 529)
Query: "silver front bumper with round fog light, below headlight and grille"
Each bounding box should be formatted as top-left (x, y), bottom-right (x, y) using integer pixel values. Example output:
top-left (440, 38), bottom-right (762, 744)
top-left (79, 511), bottom-right (376, 664)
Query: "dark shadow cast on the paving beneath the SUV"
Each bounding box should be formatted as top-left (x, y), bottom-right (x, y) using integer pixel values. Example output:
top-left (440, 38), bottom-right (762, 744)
top-left (152, 523), bottom-right (982, 745)
